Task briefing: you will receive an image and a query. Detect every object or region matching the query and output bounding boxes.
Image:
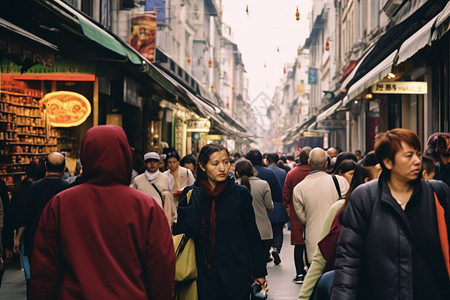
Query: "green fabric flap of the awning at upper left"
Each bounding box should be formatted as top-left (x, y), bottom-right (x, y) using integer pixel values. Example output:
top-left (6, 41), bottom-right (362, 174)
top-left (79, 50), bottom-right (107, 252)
top-left (76, 13), bottom-right (142, 65)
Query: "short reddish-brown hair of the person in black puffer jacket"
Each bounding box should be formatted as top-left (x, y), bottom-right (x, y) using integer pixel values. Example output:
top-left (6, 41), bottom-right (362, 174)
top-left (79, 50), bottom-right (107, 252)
top-left (375, 128), bottom-right (422, 173)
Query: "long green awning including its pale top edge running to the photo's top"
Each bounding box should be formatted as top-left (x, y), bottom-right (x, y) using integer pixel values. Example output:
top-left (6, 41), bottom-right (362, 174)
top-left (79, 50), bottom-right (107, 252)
top-left (53, 0), bottom-right (143, 65)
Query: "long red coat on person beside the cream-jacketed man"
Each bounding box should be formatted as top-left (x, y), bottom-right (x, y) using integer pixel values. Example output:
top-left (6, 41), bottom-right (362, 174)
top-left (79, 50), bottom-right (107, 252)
top-left (283, 165), bottom-right (310, 245)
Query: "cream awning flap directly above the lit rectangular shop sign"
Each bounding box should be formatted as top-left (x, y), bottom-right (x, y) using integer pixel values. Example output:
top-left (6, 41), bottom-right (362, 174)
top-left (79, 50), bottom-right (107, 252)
top-left (396, 16), bottom-right (437, 65)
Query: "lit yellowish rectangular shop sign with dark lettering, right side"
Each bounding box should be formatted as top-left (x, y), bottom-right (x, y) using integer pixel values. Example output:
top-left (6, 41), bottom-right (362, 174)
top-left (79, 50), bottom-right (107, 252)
top-left (372, 81), bottom-right (428, 94)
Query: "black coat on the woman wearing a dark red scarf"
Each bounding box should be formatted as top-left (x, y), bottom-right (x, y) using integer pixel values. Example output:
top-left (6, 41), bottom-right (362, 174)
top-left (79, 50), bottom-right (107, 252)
top-left (173, 178), bottom-right (267, 300)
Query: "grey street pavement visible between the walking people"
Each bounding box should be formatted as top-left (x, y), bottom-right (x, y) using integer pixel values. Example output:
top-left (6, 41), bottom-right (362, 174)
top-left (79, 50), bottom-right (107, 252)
top-left (0, 228), bottom-right (301, 300)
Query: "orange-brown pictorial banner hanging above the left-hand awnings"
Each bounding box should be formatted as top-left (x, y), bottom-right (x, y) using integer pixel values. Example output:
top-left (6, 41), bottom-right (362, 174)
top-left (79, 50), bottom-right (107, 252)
top-left (130, 12), bottom-right (156, 62)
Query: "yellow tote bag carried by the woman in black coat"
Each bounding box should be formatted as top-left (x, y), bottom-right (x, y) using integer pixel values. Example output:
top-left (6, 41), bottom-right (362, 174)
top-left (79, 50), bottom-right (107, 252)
top-left (173, 189), bottom-right (197, 282)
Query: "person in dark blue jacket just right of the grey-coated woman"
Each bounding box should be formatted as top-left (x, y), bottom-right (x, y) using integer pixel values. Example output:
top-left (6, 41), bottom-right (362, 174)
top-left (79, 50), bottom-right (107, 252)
top-left (245, 149), bottom-right (288, 265)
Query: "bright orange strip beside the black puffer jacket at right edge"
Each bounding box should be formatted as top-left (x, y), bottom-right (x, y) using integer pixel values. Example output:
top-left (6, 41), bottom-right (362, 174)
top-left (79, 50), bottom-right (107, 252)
top-left (428, 180), bottom-right (450, 278)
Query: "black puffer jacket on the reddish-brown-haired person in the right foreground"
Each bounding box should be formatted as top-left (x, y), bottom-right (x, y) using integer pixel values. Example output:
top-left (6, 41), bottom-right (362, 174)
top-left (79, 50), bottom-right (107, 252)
top-left (331, 176), bottom-right (450, 300)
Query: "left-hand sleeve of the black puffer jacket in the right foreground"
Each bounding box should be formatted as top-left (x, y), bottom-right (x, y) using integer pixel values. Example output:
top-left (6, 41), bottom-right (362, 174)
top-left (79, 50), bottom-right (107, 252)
top-left (331, 181), bottom-right (377, 300)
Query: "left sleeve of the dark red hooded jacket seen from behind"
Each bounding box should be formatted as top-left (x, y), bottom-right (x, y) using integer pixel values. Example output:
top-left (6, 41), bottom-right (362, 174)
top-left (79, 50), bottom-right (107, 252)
top-left (31, 197), bottom-right (62, 300)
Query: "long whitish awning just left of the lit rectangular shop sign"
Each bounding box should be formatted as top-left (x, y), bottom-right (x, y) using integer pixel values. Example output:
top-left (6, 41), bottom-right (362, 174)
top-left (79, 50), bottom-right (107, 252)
top-left (342, 50), bottom-right (398, 106)
